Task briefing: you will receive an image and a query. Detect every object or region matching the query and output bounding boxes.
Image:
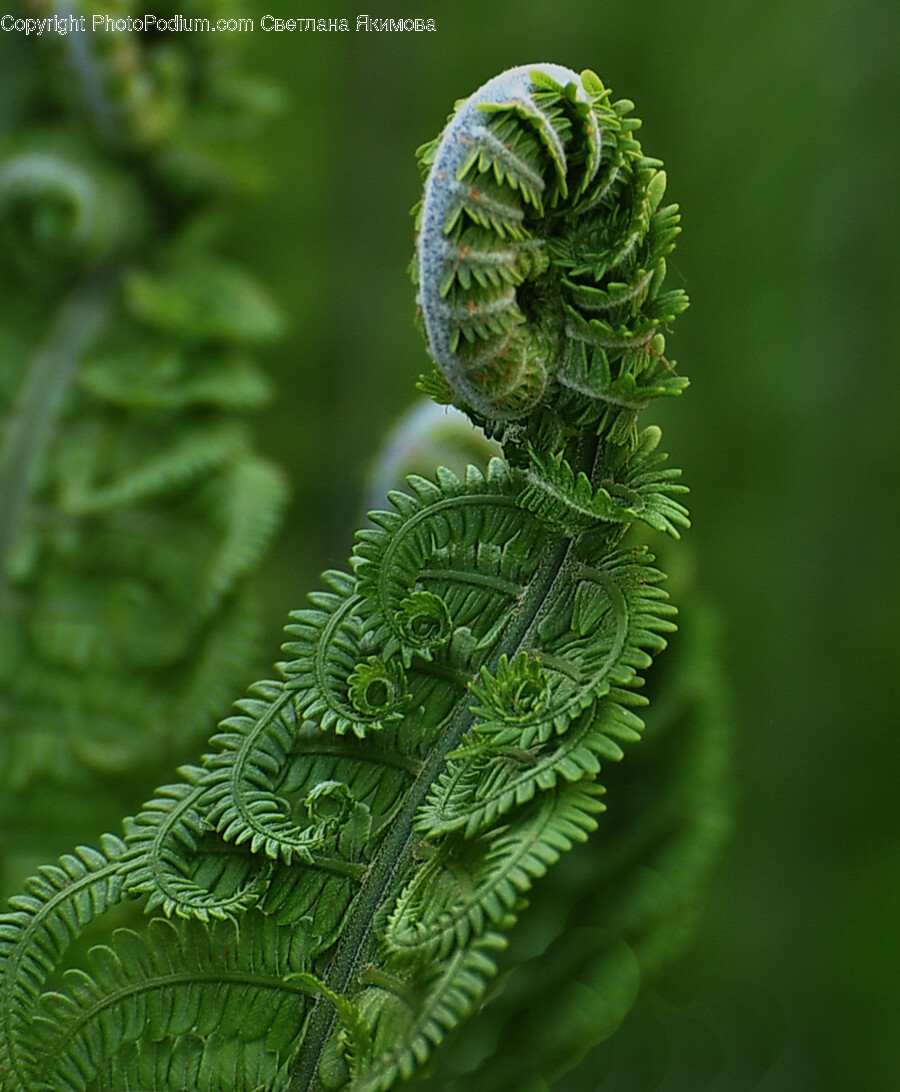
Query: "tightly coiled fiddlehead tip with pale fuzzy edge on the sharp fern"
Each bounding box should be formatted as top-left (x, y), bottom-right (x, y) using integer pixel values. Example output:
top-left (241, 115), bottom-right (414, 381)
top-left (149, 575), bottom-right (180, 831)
top-left (415, 64), bottom-right (686, 434)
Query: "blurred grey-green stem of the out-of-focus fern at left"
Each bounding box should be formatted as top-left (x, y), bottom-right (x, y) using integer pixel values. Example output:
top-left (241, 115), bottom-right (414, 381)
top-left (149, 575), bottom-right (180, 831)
top-left (0, 270), bottom-right (113, 618)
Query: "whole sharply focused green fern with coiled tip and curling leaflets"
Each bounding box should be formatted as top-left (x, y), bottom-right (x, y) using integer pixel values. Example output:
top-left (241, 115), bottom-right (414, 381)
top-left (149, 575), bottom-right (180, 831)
top-left (0, 64), bottom-right (722, 1092)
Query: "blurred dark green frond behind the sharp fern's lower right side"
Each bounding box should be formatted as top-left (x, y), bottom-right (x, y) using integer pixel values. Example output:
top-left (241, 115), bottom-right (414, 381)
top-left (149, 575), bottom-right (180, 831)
top-left (429, 587), bottom-right (731, 1092)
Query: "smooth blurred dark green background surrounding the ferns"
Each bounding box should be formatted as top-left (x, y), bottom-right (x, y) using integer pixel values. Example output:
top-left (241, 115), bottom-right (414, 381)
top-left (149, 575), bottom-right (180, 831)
top-left (230, 0), bottom-right (900, 1092)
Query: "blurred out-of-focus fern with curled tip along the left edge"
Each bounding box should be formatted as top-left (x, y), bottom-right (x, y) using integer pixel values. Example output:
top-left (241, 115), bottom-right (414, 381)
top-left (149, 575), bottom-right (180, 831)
top-left (0, 5), bottom-right (286, 890)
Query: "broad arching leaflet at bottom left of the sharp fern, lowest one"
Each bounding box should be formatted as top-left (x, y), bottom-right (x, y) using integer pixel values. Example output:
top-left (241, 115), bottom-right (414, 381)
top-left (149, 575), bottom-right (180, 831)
top-left (34, 914), bottom-right (310, 1092)
